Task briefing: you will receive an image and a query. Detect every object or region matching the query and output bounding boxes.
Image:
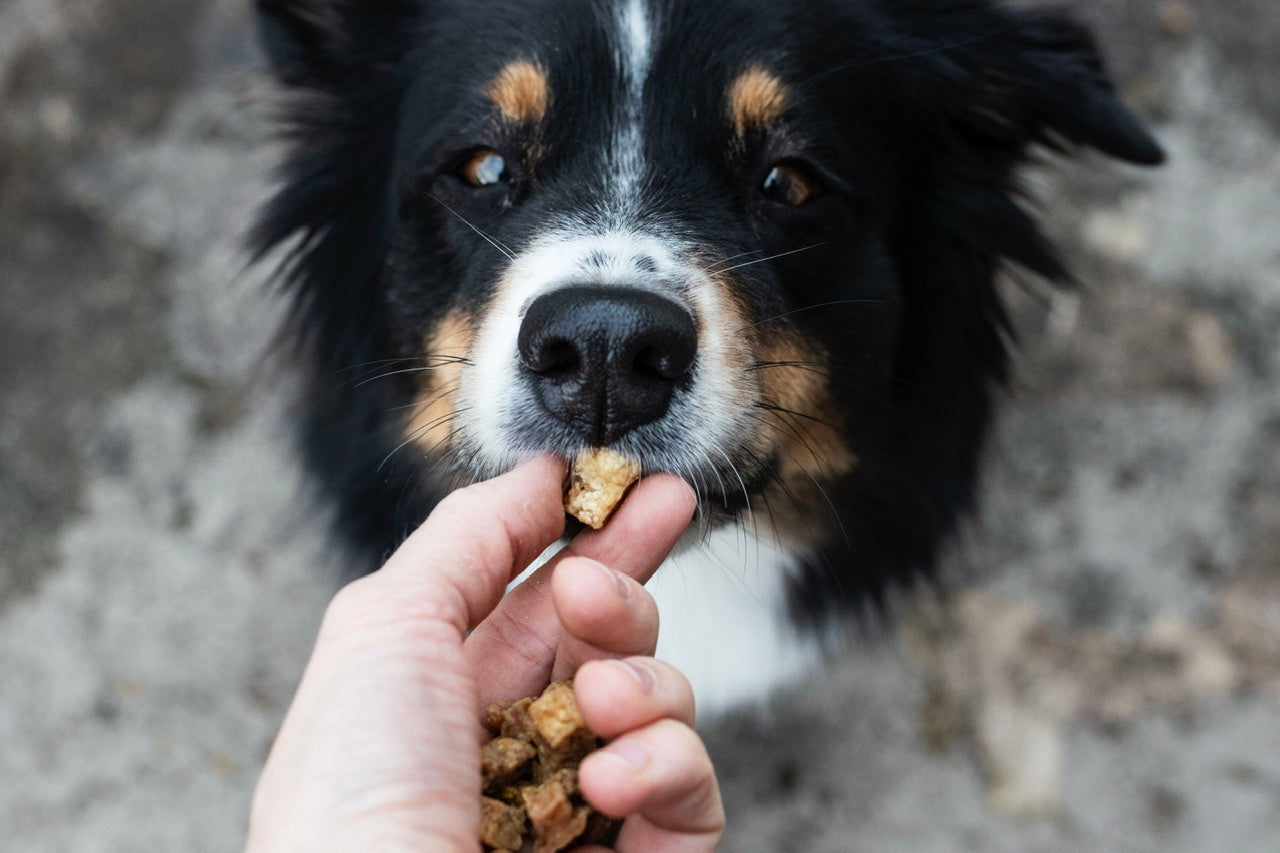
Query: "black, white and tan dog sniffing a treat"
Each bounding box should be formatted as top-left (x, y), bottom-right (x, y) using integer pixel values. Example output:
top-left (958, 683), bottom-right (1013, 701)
top-left (253, 0), bottom-right (1162, 706)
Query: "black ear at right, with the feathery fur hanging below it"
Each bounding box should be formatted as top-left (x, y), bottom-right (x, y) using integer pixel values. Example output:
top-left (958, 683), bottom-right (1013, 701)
top-left (893, 0), bottom-right (1164, 282)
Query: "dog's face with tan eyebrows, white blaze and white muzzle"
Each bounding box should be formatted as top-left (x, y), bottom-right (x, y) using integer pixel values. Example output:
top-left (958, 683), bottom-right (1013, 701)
top-left (389, 0), bottom-right (901, 525)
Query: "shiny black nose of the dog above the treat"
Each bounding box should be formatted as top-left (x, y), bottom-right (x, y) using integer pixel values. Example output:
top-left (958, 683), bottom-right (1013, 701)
top-left (520, 286), bottom-right (698, 444)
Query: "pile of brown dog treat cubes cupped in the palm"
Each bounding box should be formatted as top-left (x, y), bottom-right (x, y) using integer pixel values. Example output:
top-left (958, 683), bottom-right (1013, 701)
top-left (480, 681), bottom-right (621, 853)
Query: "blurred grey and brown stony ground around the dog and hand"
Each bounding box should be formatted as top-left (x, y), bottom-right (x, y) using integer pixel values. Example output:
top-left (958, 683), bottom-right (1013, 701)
top-left (0, 0), bottom-right (1280, 853)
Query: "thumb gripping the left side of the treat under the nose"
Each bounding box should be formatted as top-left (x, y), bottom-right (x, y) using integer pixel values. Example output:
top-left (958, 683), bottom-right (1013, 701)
top-left (370, 456), bottom-right (564, 635)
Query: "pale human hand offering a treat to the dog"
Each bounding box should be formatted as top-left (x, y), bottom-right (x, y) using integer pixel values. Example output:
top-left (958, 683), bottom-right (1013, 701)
top-left (240, 459), bottom-right (724, 853)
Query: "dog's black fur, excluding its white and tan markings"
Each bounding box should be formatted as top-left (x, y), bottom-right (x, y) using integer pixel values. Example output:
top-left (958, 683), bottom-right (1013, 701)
top-left (255, 0), bottom-right (1161, 619)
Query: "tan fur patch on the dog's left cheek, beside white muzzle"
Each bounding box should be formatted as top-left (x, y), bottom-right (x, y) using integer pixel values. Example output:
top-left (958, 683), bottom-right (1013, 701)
top-left (404, 311), bottom-right (476, 453)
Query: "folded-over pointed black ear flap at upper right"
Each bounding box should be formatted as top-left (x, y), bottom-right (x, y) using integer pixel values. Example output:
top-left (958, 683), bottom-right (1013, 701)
top-left (943, 10), bottom-right (1165, 165)
